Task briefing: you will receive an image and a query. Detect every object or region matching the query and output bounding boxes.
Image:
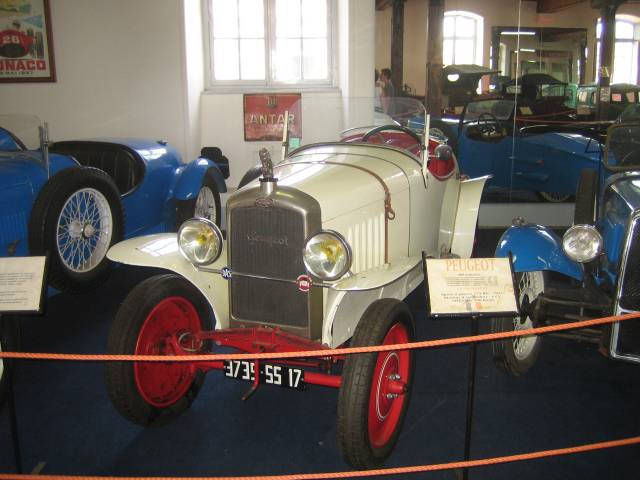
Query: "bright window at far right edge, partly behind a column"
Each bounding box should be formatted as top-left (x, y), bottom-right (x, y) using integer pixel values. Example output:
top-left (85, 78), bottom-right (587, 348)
top-left (596, 19), bottom-right (640, 84)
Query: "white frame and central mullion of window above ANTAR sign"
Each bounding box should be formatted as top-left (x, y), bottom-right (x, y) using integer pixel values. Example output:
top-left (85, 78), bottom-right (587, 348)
top-left (202, 0), bottom-right (338, 93)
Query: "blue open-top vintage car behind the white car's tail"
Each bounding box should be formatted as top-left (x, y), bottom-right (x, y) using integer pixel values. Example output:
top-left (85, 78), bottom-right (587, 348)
top-left (409, 99), bottom-right (604, 202)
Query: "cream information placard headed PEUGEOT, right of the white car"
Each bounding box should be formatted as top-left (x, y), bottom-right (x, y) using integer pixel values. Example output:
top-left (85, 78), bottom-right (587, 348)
top-left (425, 258), bottom-right (518, 315)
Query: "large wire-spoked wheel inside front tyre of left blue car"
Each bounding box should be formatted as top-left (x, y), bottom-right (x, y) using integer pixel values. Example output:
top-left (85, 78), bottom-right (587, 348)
top-left (56, 188), bottom-right (113, 273)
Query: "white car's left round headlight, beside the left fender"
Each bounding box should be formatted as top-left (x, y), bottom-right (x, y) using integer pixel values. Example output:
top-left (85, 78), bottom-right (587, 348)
top-left (178, 218), bottom-right (222, 265)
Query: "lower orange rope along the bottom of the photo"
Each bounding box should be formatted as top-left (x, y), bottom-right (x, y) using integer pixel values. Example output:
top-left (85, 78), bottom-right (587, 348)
top-left (0, 437), bottom-right (640, 480)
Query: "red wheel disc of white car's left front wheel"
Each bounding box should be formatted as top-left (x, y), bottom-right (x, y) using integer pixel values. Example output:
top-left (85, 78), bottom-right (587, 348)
top-left (133, 297), bottom-right (202, 407)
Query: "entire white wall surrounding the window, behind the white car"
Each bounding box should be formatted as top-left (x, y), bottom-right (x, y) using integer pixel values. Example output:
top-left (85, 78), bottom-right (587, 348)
top-left (0, 0), bottom-right (375, 186)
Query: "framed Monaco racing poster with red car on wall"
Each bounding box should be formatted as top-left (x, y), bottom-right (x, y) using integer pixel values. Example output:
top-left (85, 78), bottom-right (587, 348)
top-left (0, 0), bottom-right (56, 83)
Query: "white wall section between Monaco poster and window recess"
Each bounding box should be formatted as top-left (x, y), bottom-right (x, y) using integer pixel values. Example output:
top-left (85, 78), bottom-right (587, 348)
top-left (0, 0), bottom-right (187, 154)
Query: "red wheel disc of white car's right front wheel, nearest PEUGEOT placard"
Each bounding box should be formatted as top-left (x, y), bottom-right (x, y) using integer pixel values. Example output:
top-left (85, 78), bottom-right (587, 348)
top-left (369, 323), bottom-right (411, 448)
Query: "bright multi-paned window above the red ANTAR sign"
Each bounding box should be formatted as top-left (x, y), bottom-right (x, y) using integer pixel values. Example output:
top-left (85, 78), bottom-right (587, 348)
top-left (208, 0), bottom-right (332, 87)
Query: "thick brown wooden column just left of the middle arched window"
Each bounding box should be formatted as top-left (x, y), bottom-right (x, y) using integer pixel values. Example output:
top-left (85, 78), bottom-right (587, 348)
top-left (425, 0), bottom-right (444, 117)
